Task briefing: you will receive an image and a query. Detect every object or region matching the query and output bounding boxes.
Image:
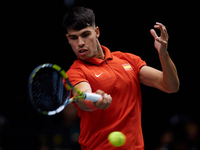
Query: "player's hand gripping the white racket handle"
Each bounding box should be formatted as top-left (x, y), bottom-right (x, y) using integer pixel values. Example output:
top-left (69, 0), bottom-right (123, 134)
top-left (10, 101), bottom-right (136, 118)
top-left (93, 90), bottom-right (112, 109)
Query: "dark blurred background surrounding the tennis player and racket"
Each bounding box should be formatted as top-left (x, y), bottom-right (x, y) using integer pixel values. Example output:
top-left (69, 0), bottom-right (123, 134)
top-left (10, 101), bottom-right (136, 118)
top-left (0, 0), bottom-right (200, 150)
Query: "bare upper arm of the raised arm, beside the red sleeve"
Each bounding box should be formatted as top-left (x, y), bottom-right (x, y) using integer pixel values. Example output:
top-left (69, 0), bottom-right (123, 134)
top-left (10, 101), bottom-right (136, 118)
top-left (139, 66), bottom-right (165, 91)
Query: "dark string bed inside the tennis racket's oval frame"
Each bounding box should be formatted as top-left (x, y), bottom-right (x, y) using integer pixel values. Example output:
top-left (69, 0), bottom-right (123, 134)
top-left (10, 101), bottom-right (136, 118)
top-left (32, 68), bottom-right (66, 111)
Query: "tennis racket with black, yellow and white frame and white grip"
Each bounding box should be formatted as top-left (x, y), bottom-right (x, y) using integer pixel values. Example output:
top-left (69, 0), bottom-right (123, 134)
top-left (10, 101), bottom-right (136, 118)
top-left (28, 63), bottom-right (101, 115)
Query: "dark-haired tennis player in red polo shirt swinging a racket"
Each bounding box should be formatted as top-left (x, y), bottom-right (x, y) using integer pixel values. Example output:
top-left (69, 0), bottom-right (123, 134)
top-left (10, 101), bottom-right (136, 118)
top-left (63, 7), bottom-right (179, 150)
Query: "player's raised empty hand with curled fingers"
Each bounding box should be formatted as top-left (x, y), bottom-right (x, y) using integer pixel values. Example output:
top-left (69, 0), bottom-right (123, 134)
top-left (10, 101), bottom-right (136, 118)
top-left (150, 22), bottom-right (169, 54)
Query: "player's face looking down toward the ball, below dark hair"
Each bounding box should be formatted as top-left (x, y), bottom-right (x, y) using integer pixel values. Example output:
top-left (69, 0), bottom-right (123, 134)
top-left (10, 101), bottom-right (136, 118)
top-left (66, 27), bottom-right (100, 60)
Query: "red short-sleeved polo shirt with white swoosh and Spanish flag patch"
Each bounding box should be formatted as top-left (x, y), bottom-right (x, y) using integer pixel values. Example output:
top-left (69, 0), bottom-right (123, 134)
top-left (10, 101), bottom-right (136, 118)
top-left (67, 46), bottom-right (146, 150)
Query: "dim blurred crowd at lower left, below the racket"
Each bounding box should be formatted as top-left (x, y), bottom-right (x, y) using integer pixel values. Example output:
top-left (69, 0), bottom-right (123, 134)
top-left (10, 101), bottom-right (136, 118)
top-left (0, 104), bottom-right (80, 150)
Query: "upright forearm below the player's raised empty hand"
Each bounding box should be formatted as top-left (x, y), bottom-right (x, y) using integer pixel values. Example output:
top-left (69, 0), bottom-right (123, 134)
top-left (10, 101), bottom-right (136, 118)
top-left (159, 51), bottom-right (180, 93)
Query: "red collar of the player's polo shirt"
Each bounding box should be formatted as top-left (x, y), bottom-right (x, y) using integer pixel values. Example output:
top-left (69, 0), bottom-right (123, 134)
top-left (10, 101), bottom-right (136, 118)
top-left (79, 45), bottom-right (113, 66)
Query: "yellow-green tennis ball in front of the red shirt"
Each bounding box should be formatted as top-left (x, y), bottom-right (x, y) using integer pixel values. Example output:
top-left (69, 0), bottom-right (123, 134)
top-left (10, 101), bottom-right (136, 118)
top-left (108, 131), bottom-right (126, 147)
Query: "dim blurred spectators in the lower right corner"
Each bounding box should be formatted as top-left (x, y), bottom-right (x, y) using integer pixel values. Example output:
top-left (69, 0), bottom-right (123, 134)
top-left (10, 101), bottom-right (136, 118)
top-left (155, 115), bottom-right (200, 150)
